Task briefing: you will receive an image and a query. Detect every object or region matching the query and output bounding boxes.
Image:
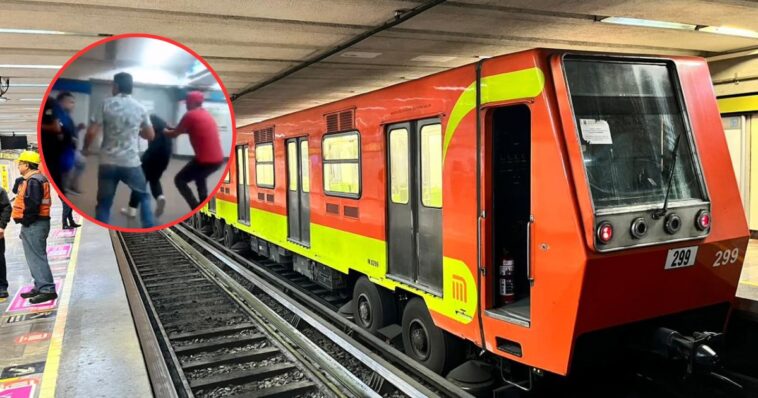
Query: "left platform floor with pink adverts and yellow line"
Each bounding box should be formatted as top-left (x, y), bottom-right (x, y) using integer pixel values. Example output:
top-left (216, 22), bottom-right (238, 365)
top-left (0, 198), bottom-right (152, 398)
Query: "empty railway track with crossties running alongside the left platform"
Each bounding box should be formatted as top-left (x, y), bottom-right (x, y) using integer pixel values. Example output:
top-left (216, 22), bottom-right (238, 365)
top-left (120, 232), bottom-right (378, 397)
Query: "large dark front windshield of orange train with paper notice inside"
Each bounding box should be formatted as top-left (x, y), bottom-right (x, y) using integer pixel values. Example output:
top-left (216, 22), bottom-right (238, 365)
top-left (564, 57), bottom-right (704, 210)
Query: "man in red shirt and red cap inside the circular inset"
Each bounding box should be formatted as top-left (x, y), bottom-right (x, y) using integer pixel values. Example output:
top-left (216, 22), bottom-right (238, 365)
top-left (164, 91), bottom-right (224, 210)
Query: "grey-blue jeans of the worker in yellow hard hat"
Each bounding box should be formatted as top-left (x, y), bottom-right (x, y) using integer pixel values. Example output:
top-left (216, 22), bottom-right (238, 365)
top-left (19, 219), bottom-right (55, 293)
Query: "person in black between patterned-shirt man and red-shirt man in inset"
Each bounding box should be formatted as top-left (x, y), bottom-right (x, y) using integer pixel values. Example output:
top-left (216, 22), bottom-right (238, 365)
top-left (121, 115), bottom-right (171, 218)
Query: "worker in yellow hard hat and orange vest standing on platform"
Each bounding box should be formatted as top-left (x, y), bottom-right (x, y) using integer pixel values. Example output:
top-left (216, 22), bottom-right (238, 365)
top-left (11, 151), bottom-right (58, 304)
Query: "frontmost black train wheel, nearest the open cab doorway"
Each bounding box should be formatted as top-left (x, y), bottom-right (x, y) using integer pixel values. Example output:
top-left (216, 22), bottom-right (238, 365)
top-left (403, 297), bottom-right (454, 374)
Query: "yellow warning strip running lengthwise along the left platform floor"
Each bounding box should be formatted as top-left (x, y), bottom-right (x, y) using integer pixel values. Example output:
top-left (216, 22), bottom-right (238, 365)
top-left (39, 227), bottom-right (82, 398)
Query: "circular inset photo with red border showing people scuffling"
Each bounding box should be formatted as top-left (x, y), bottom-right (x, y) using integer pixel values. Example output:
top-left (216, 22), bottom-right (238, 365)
top-left (38, 34), bottom-right (235, 232)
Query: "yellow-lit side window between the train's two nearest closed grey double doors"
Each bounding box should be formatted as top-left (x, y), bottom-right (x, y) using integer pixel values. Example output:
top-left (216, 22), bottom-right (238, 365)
top-left (322, 131), bottom-right (361, 198)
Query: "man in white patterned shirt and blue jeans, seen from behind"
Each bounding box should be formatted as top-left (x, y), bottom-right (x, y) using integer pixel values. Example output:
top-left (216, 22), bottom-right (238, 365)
top-left (84, 72), bottom-right (155, 228)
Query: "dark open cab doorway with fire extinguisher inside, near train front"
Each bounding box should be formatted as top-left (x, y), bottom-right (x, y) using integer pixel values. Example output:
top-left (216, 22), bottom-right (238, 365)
top-left (487, 104), bottom-right (532, 326)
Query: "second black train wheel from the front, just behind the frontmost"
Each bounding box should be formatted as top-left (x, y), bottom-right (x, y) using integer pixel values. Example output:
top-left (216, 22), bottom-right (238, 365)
top-left (353, 276), bottom-right (395, 333)
